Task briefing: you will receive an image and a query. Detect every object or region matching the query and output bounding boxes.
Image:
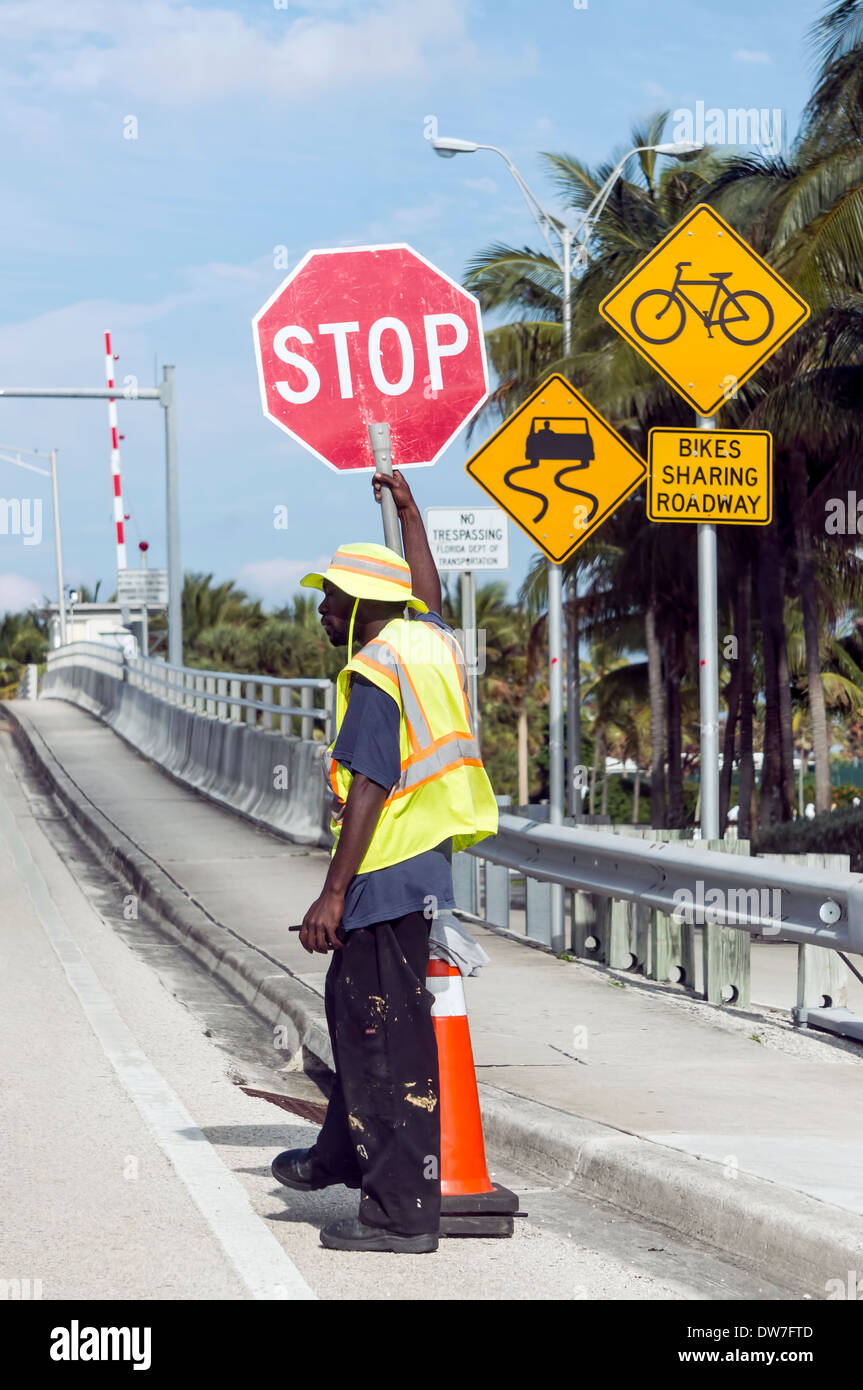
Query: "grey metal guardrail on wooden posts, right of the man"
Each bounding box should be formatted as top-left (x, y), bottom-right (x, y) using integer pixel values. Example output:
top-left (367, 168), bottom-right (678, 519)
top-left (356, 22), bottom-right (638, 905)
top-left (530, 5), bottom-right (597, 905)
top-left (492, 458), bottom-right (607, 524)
top-left (453, 812), bottom-right (863, 1041)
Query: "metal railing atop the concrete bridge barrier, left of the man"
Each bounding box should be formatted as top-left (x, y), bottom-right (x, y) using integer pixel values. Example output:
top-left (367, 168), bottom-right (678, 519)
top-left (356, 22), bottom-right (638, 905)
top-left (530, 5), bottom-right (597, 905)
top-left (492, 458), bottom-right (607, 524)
top-left (47, 642), bottom-right (335, 741)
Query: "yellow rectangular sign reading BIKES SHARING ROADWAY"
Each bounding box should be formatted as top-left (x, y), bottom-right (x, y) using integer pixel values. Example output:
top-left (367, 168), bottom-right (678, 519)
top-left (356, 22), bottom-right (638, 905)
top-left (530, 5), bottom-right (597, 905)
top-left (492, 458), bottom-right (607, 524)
top-left (648, 430), bottom-right (773, 525)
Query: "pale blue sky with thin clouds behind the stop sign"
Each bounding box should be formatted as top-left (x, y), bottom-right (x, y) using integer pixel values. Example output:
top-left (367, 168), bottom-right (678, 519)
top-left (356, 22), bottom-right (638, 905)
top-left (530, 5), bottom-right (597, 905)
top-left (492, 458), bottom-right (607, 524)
top-left (0, 0), bottom-right (823, 612)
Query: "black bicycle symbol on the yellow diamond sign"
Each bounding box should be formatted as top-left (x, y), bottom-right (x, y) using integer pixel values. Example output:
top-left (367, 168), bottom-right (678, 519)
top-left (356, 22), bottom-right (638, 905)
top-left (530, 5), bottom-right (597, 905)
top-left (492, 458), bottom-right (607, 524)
top-left (631, 261), bottom-right (773, 348)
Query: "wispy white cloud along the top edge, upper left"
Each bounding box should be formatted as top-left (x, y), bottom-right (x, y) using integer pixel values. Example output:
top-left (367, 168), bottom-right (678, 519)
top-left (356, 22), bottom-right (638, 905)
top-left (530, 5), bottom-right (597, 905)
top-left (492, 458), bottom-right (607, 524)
top-left (0, 0), bottom-right (478, 103)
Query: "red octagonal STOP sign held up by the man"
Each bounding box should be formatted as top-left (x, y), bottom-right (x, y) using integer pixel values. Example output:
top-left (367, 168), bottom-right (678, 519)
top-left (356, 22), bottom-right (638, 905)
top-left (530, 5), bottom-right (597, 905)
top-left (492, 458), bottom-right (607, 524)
top-left (252, 245), bottom-right (488, 473)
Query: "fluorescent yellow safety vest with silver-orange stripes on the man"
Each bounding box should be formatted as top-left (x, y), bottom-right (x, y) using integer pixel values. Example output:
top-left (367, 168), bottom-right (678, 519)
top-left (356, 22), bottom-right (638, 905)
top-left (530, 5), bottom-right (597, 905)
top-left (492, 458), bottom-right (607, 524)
top-left (328, 619), bottom-right (498, 873)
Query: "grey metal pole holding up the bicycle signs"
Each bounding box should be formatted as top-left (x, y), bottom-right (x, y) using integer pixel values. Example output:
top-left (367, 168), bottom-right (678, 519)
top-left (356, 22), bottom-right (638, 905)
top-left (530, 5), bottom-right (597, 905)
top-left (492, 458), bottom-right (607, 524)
top-left (695, 416), bottom-right (721, 840)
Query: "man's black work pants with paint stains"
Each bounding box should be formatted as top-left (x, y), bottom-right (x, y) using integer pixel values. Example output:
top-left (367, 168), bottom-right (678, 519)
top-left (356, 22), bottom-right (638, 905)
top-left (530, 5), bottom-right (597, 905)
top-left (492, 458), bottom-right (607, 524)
top-left (314, 912), bottom-right (441, 1236)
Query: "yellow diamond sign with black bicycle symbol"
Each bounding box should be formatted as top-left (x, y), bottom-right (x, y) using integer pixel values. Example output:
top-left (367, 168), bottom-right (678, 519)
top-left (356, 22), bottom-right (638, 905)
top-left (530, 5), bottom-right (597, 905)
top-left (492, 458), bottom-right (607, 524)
top-left (599, 203), bottom-right (809, 416)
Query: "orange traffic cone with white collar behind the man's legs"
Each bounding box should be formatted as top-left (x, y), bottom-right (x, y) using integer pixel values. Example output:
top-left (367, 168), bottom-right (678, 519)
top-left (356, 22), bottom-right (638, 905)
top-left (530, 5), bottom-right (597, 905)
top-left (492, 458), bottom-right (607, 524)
top-left (425, 959), bottom-right (518, 1236)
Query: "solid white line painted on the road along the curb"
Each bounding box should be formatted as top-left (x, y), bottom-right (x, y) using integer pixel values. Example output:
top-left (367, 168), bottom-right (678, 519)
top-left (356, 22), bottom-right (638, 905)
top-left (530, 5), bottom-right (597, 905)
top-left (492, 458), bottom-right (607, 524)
top-left (0, 802), bottom-right (317, 1301)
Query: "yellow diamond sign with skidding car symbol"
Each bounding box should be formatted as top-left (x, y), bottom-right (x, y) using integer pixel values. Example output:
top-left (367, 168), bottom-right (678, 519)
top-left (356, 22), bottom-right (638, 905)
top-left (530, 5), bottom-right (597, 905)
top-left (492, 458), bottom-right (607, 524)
top-left (466, 375), bottom-right (648, 564)
